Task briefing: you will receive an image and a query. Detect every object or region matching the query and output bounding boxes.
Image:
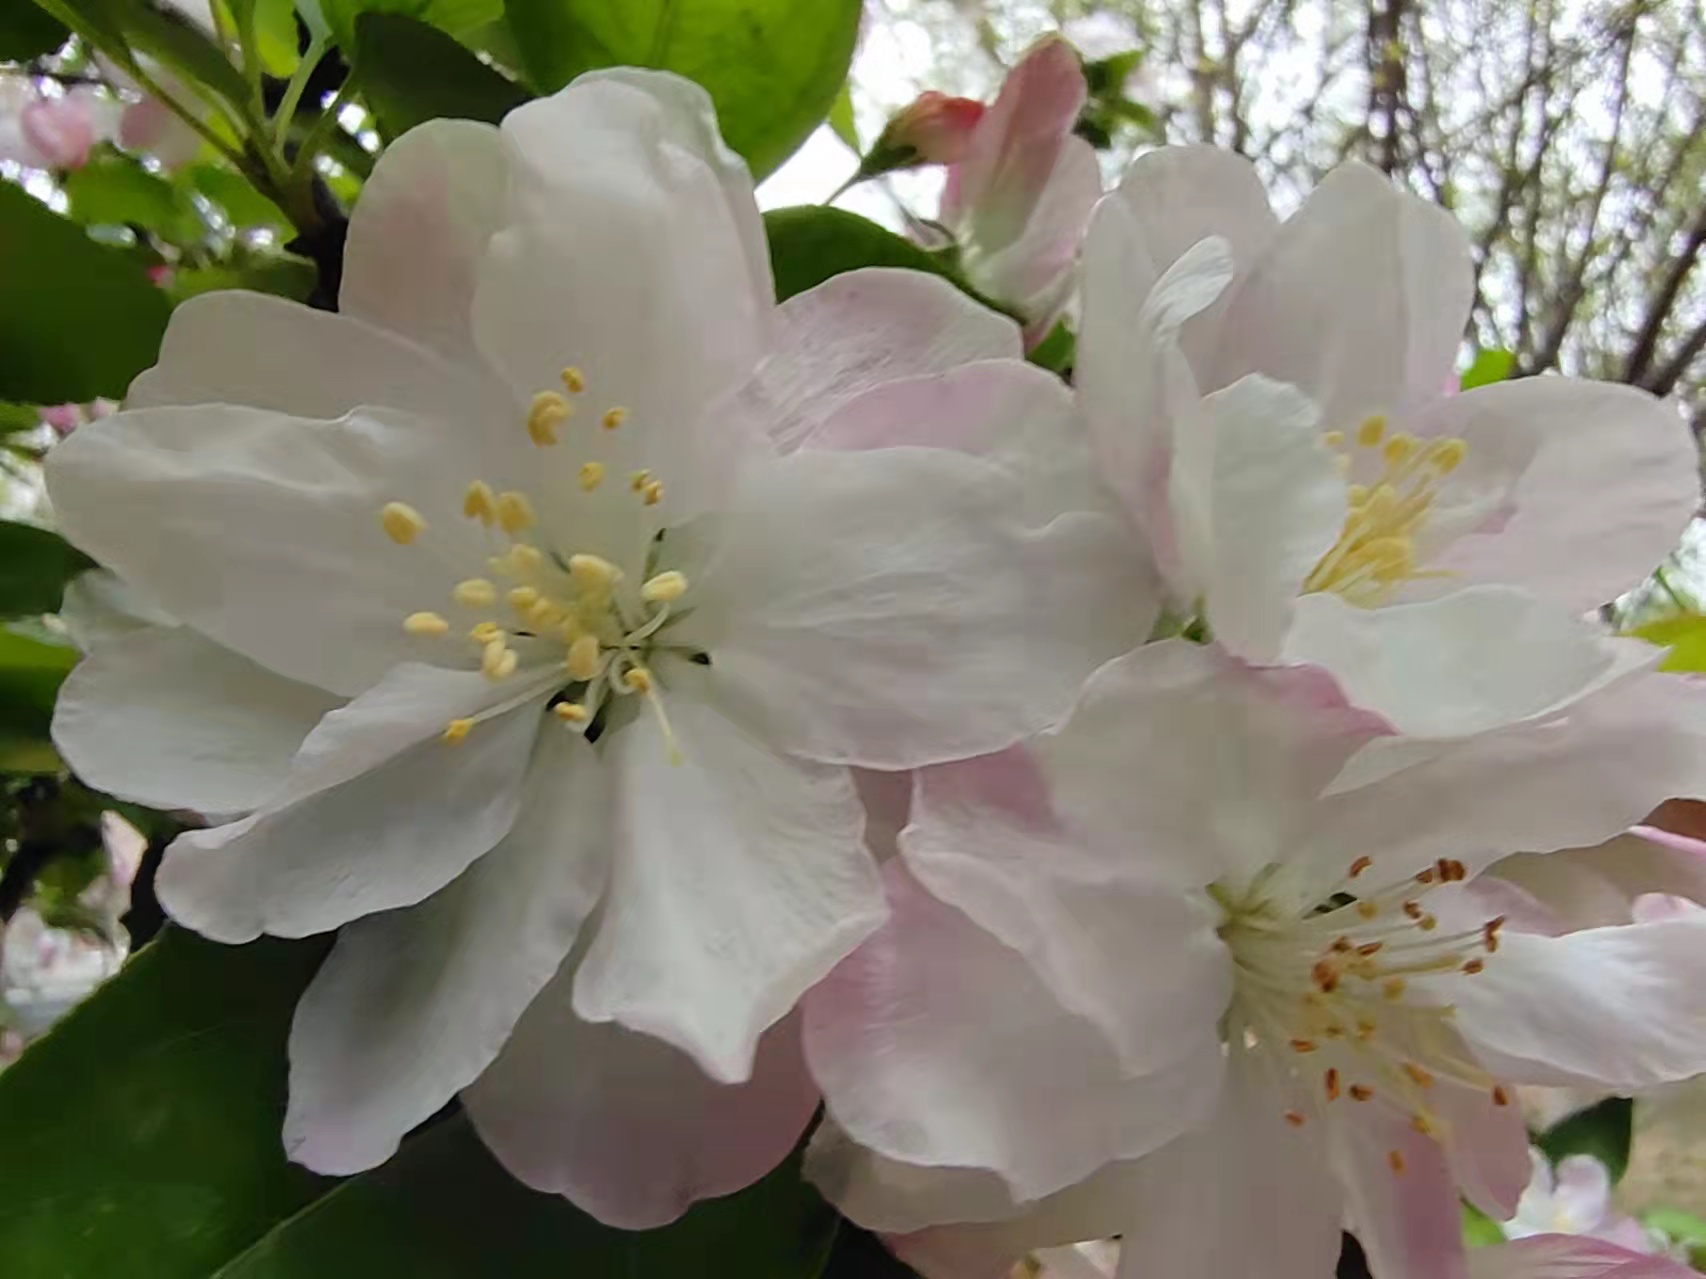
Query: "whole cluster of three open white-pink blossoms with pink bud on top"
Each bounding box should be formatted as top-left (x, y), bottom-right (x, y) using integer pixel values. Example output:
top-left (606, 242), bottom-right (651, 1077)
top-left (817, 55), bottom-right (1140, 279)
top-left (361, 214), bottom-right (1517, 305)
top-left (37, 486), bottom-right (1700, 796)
top-left (36, 43), bottom-right (1706, 1279)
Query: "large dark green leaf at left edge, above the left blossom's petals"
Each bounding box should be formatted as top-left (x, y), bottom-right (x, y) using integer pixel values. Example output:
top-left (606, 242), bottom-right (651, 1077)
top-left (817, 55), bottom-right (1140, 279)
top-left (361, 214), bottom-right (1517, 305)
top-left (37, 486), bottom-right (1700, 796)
top-left (0, 182), bottom-right (171, 404)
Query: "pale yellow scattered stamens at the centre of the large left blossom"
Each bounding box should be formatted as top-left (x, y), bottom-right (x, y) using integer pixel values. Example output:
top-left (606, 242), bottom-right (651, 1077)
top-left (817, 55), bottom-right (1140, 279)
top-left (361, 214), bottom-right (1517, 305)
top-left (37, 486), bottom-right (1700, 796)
top-left (380, 368), bottom-right (692, 762)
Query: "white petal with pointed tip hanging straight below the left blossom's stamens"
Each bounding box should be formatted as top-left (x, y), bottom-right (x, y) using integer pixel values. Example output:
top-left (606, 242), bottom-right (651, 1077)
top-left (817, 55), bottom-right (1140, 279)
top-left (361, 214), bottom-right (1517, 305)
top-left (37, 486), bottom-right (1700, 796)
top-left (575, 692), bottom-right (884, 1083)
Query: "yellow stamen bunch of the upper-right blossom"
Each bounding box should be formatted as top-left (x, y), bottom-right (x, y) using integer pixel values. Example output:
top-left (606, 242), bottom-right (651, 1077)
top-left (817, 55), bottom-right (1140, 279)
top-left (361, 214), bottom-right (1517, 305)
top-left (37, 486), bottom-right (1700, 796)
top-left (1303, 416), bottom-right (1469, 609)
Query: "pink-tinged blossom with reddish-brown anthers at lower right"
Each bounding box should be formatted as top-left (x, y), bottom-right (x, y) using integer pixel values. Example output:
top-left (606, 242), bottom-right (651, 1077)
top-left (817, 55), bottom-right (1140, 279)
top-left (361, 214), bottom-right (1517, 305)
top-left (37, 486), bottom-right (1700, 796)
top-left (805, 641), bottom-right (1706, 1279)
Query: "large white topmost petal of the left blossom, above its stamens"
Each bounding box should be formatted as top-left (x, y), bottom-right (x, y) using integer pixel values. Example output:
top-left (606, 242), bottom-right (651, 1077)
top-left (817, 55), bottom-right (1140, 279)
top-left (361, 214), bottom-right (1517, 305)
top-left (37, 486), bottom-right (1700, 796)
top-left (474, 70), bottom-right (773, 446)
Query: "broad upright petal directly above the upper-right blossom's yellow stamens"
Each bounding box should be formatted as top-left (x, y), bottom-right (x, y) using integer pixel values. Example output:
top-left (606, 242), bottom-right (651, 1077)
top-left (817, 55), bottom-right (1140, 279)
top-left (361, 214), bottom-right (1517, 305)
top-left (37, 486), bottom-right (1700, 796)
top-left (1206, 164), bottom-right (1472, 430)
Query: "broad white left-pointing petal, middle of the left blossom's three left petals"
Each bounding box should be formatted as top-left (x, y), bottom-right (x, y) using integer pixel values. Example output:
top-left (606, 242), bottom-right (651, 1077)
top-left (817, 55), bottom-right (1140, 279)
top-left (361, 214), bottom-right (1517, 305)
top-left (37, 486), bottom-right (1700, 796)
top-left (48, 404), bottom-right (503, 696)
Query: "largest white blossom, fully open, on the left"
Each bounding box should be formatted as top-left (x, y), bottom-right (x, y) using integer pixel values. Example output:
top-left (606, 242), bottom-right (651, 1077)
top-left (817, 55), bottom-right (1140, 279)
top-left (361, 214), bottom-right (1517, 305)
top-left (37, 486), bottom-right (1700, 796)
top-left (48, 72), bottom-right (1155, 1226)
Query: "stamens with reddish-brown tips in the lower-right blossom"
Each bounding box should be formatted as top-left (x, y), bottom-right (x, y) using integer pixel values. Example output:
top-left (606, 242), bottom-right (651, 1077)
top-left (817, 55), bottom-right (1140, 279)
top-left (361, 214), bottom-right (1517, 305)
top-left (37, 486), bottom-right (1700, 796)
top-left (1210, 858), bottom-right (1510, 1172)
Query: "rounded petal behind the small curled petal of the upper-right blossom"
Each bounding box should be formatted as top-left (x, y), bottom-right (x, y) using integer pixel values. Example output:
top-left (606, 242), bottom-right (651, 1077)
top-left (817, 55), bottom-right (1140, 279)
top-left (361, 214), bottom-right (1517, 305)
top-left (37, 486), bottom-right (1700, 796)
top-left (1109, 147), bottom-right (1280, 377)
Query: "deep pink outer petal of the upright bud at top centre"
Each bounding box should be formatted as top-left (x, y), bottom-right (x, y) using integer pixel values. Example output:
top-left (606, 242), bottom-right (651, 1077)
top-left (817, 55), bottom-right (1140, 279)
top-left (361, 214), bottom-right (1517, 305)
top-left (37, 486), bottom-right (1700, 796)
top-left (940, 38), bottom-right (1087, 251)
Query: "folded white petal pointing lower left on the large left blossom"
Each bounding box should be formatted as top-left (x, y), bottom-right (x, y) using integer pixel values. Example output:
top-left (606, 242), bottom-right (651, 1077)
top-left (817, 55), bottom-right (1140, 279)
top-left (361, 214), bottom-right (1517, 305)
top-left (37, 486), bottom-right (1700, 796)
top-left (159, 667), bottom-right (544, 941)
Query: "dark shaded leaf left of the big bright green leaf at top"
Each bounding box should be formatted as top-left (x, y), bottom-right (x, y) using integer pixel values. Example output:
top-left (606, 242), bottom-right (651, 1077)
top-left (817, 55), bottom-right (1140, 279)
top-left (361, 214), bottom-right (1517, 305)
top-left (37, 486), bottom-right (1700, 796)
top-left (357, 14), bottom-right (532, 136)
